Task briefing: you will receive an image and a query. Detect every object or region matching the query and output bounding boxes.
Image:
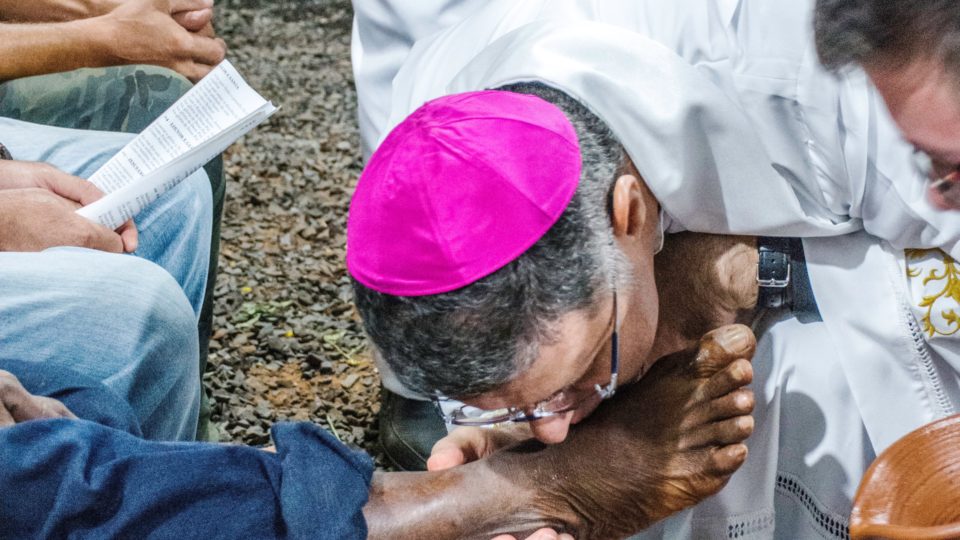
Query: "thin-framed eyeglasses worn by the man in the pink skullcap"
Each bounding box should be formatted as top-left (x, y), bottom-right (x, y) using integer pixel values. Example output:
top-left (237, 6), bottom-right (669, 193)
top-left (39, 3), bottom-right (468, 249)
top-left (434, 291), bottom-right (620, 426)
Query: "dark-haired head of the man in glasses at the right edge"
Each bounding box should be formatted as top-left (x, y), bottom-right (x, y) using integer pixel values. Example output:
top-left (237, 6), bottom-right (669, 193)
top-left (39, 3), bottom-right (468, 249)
top-left (815, 0), bottom-right (960, 209)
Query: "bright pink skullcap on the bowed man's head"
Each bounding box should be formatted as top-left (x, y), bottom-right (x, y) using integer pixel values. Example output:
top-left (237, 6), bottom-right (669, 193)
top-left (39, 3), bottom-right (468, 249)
top-left (347, 90), bottom-right (580, 296)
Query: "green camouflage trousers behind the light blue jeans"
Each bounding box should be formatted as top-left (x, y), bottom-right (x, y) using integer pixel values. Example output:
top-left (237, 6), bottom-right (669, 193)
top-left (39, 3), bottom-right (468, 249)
top-left (0, 66), bottom-right (226, 440)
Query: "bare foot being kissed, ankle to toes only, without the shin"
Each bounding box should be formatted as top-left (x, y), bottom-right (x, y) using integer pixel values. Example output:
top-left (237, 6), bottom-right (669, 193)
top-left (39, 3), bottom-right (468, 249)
top-left (516, 325), bottom-right (756, 540)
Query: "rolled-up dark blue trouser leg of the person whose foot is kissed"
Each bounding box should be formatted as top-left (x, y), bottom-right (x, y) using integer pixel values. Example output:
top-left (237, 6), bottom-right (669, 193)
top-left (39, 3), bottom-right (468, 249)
top-left (0, 419), bottom-right (373, 539)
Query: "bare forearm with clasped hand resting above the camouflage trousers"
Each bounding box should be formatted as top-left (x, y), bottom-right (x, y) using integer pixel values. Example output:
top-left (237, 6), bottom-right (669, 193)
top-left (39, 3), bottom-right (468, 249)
top-left (0, 0), bottom-right (226, 81)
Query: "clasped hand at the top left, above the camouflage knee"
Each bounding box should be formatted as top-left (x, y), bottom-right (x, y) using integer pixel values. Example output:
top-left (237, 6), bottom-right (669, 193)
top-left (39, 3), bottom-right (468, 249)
top-left (101, 0), bottom-right (227, 82)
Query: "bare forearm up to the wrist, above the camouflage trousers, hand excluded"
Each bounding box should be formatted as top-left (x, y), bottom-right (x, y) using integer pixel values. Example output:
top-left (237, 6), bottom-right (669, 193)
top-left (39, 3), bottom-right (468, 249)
top-left (0, 19), bottom-right (117, 80)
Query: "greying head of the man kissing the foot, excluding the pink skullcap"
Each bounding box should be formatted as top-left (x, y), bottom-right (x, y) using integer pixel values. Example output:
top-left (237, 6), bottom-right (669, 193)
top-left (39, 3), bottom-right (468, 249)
top-left (349, 84), bottom-right (659, 442)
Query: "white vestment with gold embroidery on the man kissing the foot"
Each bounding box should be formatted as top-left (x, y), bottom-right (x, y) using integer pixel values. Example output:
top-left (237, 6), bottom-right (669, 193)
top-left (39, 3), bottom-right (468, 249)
top-left (361, 0), bottom-right (960, 539)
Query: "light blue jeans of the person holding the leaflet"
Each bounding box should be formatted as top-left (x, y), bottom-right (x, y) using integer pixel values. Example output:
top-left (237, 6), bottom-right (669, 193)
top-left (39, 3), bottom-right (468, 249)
top-left (0, 118), bottom-right (212, 440)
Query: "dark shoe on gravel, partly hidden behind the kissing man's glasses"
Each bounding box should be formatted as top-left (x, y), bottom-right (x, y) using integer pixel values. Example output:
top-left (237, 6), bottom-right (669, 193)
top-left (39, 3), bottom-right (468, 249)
top-left (379, 388), bottom-right (447, 471)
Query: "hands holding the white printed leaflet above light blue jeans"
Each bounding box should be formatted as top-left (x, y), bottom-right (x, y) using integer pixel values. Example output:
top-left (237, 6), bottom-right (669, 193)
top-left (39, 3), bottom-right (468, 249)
top-left (0, 160), bottom-right (137, 253)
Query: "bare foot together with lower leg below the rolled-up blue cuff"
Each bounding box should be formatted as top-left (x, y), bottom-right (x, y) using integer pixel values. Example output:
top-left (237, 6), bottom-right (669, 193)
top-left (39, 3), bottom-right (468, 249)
top-left (364, 325), bottom-right (756, 540)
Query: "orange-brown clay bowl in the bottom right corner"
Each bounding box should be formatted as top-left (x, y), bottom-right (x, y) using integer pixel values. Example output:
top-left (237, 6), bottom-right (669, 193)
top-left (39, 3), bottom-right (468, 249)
top-left (850, 414), bottom-right (960, 540)
